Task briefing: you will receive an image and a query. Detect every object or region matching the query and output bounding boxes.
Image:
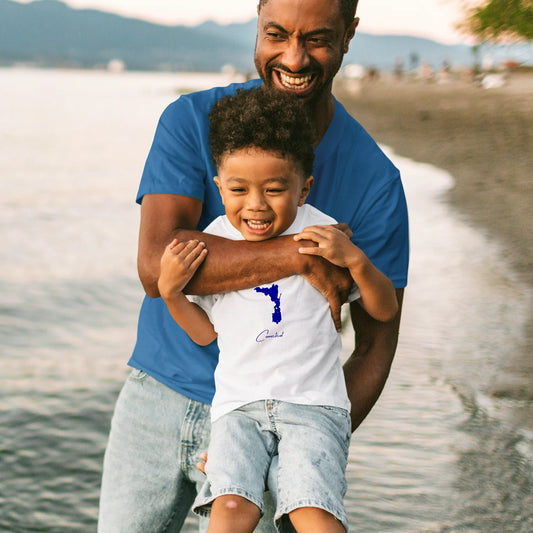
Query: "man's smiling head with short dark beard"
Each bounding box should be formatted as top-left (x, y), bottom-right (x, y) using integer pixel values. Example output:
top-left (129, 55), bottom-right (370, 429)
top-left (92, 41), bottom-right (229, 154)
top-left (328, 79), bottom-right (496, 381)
top-left (255, 0), bottom-right (355, 104)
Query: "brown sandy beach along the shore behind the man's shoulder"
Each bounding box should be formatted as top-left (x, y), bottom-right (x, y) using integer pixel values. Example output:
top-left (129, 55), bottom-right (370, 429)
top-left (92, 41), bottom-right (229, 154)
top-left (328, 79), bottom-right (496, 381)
top-left (335, 72), bottom-right (533, 402)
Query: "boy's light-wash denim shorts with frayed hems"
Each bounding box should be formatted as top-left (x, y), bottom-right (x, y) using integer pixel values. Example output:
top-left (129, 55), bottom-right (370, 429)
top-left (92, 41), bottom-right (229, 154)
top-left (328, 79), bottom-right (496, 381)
top-left (193, 400), bottom-right (351, 531)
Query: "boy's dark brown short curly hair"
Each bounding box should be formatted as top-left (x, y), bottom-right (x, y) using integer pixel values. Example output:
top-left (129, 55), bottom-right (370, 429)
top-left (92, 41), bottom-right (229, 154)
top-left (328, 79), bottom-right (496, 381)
top-left (209, 87), bottom-right (314, 178)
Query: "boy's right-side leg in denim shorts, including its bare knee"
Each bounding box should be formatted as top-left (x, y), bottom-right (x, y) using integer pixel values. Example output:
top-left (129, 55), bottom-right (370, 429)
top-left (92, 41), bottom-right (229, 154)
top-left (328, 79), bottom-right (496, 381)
top-left (273, 402), bottom-right (351, 533)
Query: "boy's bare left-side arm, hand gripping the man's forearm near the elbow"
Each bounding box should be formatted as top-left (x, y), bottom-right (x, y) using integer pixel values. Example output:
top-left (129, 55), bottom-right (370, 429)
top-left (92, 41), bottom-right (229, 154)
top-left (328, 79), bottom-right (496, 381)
top-left (158, 239), bottom-right (217, 346)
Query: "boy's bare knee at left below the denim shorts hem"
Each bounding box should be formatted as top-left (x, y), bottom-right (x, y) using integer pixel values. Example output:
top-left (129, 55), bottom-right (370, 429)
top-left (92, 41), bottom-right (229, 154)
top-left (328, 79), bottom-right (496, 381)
top-left (207, 494), bottom-right (261, 533)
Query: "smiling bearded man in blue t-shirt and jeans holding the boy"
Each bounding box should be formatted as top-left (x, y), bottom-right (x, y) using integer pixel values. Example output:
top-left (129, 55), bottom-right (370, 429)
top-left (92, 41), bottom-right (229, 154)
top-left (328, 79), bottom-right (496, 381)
top-left (99, 0), bottom-right (408, 533)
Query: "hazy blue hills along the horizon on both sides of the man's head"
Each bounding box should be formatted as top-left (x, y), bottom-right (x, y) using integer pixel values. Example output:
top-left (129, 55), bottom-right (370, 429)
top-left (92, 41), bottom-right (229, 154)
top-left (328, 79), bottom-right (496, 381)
top-left (0, 0), bottom-right (533, 72)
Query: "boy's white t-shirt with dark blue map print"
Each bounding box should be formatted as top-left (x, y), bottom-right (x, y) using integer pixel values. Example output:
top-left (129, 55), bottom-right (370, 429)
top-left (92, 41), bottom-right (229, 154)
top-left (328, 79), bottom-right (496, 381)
top-left (189, 204), bottom-right (359, 420)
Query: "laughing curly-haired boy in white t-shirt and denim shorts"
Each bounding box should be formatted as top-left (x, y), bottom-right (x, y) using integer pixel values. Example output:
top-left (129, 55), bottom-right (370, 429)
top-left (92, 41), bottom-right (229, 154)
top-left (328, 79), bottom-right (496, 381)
top-left (158, 88), bottom-right (398, 533)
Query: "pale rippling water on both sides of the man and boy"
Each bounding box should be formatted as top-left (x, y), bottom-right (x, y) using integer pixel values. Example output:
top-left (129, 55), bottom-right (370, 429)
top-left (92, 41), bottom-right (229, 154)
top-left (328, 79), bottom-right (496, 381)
top-left (0, 69), bottom-right (533, 533)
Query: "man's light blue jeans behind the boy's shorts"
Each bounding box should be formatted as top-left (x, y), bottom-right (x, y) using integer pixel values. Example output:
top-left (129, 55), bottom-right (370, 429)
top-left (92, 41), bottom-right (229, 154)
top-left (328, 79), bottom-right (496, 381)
top-left (98, 370), bottom-right (275, 533)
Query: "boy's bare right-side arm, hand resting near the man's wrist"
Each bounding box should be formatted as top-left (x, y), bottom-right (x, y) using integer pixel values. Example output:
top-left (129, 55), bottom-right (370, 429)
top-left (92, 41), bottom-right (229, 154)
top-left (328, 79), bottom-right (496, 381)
top-left (294, 225), bottom-right (398, 322)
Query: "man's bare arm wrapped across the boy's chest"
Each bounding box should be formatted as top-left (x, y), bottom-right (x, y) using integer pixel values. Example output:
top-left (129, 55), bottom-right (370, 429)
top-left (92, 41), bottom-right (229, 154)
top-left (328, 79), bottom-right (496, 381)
top-left (137, 194), bottom-right (352, 327)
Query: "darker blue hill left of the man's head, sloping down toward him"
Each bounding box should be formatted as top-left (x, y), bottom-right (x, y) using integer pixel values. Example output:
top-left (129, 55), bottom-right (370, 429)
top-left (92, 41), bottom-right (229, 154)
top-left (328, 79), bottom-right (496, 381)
top-left (0, 0), bottom-right (253, 71)
